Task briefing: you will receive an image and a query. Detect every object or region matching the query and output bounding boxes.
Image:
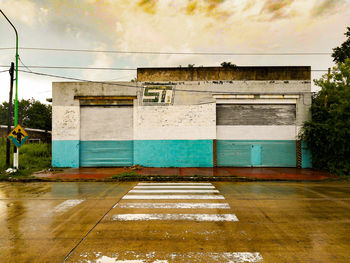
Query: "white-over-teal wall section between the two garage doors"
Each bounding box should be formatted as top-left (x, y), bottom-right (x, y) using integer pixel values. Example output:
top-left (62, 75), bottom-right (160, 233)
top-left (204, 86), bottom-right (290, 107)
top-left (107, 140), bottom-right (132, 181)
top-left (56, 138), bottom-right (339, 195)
top-left (134, 103), bottom-right (216, 167)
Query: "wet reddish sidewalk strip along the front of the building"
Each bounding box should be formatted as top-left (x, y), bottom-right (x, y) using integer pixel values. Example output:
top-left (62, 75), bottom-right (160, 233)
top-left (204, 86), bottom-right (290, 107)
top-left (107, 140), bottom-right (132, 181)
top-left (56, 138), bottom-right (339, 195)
top-left (34, 167), bottom-right (340, 181)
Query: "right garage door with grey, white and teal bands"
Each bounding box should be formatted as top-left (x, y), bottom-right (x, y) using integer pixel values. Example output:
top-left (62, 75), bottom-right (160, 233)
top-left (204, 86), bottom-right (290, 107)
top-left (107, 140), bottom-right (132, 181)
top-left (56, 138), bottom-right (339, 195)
top-left (216, 104), bottom-right (296, 167)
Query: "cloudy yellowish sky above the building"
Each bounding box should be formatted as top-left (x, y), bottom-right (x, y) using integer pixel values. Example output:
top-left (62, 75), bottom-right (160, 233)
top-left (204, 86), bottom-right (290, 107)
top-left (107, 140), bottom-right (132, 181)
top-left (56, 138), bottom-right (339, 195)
top-left (0, 0), bottom-right (350, 102)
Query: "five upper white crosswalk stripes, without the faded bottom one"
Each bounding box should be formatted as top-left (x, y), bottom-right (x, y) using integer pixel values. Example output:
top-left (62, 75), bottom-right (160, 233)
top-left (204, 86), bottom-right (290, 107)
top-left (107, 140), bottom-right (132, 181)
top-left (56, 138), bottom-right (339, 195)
top-left (112, 183), bottom-right (235, 222)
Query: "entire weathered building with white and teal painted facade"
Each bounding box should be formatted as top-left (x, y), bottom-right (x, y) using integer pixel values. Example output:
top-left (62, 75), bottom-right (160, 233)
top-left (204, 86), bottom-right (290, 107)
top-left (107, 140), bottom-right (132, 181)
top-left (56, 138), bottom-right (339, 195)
top-left (52, 67), bottom-right (311, 168)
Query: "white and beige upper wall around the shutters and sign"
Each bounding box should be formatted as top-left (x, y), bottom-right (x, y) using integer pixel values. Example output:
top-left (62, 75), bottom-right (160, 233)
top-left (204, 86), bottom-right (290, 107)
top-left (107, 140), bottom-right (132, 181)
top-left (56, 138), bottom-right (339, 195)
top-left (52, 81), bottom-right (311, 140)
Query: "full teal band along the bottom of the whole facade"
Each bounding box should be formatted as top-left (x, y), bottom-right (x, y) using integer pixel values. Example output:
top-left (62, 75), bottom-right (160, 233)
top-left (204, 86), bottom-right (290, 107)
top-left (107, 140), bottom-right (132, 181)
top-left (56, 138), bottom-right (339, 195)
top-left (52, 140), bottom-right (312, 168)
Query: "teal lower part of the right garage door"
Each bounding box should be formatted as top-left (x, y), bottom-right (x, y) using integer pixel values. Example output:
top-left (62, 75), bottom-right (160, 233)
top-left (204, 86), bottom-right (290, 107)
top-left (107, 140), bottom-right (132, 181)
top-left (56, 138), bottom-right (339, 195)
top-left (216, 140), bottom-right (296, 167)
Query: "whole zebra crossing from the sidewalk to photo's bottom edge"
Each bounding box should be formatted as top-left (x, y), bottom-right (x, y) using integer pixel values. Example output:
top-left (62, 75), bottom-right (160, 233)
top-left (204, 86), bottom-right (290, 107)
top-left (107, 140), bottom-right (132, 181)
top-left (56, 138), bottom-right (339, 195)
top-left (76, 183), bottom-right (263, 263)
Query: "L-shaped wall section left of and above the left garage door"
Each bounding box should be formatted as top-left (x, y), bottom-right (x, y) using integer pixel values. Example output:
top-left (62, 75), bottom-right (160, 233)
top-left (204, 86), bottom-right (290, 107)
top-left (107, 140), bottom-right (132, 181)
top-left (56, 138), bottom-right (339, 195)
top-left (52, 82), bottom-right (137, 167)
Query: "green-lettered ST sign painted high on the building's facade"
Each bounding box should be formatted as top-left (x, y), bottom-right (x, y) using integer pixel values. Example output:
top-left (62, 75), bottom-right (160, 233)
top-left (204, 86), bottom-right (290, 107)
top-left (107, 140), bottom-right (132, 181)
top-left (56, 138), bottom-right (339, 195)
top-left (142, 86), bottom-right (173, 105)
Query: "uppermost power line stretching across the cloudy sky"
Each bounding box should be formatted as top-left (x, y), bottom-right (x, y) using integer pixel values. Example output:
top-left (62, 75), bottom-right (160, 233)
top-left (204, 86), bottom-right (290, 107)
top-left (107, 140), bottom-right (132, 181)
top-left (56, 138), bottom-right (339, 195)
top-left (0, 47), bottom-right (332, 56)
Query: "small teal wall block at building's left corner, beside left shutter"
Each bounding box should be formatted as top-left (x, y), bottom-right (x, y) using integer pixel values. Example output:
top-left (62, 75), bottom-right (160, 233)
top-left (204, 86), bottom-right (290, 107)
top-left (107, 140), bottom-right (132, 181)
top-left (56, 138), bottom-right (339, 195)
top-left (51, 140), bottom-right (80, 168)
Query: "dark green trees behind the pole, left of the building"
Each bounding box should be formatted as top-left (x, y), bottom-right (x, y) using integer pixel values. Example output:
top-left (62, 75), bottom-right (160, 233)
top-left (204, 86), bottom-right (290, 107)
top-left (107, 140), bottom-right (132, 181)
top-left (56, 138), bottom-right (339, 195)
top-left (0, 99), bottom-right (52, 130)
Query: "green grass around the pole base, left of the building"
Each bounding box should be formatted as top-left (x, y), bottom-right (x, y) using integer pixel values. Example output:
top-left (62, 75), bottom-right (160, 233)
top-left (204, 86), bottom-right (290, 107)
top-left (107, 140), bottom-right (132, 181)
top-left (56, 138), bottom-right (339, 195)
top-left (0, 138), bottom-right (51, 178)
